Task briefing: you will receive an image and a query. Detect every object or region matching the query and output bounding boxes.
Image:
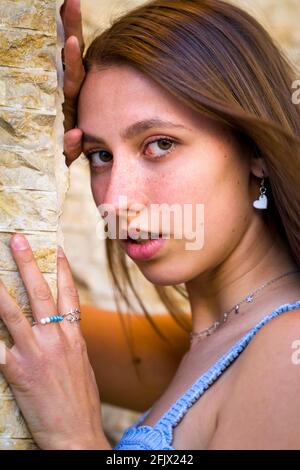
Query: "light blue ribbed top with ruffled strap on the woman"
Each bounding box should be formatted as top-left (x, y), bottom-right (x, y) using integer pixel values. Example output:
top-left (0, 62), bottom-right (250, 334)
top-left (113, 300), bottom-right (300, 450)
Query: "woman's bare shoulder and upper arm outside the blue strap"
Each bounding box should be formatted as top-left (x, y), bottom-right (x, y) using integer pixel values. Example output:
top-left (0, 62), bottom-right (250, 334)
top-left (210, 308), bottom-right (300, 449)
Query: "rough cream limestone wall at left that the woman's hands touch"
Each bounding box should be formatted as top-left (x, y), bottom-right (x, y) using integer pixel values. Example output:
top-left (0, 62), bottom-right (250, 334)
top-left (0, 0), bottom-right (68, 449)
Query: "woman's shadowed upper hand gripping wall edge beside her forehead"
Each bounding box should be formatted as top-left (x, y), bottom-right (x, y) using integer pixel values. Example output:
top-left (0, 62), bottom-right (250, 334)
top-left (61, 0), bottom-right (85, 166)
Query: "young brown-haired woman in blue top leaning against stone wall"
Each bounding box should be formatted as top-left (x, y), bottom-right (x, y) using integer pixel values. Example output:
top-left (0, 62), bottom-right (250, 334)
top-left (0, 0), bottom-right (300, 450)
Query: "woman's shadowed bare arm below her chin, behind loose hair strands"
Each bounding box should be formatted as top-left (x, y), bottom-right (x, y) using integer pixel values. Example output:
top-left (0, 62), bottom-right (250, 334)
top-left (81, 306), bottom-right (189, 412)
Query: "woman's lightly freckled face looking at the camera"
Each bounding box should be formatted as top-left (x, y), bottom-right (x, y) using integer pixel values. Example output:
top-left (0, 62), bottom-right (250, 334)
top-left (78, 65), bottom-right (259, 285)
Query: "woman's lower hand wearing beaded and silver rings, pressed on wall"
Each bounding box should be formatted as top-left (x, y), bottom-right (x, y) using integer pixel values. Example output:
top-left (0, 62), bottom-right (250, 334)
top-left (0, 235), bottom-right (111, 450)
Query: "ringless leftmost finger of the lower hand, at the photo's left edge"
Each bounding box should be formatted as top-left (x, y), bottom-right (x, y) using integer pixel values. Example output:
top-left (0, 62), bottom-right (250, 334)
top-left (0, 280), bottom-right (34, 351)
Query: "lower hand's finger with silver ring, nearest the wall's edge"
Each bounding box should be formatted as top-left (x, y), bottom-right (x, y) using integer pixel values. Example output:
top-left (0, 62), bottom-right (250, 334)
top-left (57, 247), bottom-right (80, 334)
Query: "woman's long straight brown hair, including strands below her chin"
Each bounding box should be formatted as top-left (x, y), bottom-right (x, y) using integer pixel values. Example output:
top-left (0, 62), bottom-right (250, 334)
top-left (84, 0), bottom-right (300, 362)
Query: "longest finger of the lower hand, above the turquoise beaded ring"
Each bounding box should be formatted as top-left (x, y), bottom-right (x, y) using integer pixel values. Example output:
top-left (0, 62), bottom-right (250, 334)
top-left (10, 234), bottom-right (57, 329)
